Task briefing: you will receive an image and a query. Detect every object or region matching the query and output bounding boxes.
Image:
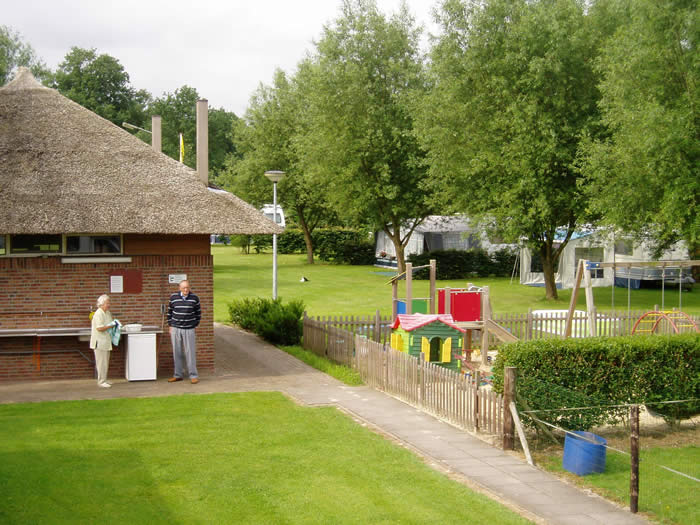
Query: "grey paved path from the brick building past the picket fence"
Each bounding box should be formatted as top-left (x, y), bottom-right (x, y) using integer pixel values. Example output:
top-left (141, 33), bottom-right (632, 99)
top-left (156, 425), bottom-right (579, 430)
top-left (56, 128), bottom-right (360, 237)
top-left (0, 325), bottom-right (646, 525)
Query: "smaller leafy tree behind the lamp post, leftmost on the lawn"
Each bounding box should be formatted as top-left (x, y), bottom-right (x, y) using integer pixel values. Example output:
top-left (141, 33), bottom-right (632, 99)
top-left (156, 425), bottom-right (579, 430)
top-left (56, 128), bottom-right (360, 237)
top-left (218, 64), bottom-right (332, 264)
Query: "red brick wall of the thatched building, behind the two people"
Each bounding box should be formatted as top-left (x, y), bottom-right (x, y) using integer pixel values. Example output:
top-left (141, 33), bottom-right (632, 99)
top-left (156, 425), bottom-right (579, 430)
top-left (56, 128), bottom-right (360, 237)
top-left (0, 250), bottom-right (214, 381)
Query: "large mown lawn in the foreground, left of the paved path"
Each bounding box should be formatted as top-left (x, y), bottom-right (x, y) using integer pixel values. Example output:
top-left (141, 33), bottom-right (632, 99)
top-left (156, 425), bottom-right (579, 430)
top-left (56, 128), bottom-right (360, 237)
top-left (0, 392), bottom-right (526, 524)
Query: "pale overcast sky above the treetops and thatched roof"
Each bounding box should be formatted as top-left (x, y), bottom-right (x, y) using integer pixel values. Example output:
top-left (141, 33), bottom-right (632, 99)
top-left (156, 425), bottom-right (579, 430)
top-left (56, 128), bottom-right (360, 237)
top-left (5, 0), bottom-right (437, 116)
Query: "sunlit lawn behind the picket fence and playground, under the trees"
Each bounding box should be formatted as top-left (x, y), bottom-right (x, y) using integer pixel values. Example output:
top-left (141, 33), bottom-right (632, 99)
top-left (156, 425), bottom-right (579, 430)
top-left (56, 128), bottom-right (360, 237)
top-left (212, 246), bottom-right (700, 322)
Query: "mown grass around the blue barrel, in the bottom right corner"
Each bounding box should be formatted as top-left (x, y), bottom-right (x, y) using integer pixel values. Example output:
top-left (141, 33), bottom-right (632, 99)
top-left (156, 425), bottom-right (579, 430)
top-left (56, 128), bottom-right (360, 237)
top-left (538, 445), bottom-right (700, 524)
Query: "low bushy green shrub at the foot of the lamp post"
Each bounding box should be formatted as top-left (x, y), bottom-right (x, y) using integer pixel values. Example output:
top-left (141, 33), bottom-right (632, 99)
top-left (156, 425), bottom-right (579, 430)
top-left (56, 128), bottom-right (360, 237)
top-left (228, 297), bottom-right (304, 345)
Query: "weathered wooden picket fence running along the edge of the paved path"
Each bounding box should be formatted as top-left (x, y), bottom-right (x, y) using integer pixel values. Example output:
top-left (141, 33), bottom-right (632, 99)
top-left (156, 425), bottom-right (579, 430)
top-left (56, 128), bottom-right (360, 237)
top-left (304, 317), bottom-right (503, 436)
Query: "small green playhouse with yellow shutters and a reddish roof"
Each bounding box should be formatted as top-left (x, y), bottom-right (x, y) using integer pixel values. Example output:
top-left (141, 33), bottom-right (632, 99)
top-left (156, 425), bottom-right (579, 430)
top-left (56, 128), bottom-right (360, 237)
top-left (391, 314), bottom-right (465, 370)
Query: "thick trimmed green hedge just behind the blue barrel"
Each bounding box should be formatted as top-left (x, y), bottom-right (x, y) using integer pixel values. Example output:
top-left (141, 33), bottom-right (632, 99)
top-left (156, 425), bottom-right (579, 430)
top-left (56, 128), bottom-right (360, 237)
top-left (494, 334), bottom-right (700, 430)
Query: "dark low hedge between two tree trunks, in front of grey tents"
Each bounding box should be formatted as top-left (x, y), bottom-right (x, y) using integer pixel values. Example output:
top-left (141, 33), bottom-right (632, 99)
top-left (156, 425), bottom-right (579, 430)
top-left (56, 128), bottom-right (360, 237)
top-left (408, 248), bottom-right (517, 280)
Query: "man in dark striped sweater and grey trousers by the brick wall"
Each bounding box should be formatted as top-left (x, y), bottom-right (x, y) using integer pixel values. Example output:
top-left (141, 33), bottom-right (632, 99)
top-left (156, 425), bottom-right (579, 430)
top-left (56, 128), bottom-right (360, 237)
top-left (168, 281), bottom-right (202, 385)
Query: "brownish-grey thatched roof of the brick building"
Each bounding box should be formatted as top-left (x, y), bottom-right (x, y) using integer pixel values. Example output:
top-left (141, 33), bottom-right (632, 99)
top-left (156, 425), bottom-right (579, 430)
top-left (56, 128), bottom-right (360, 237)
top-left (0, 68), bottom-right (282, 234)
